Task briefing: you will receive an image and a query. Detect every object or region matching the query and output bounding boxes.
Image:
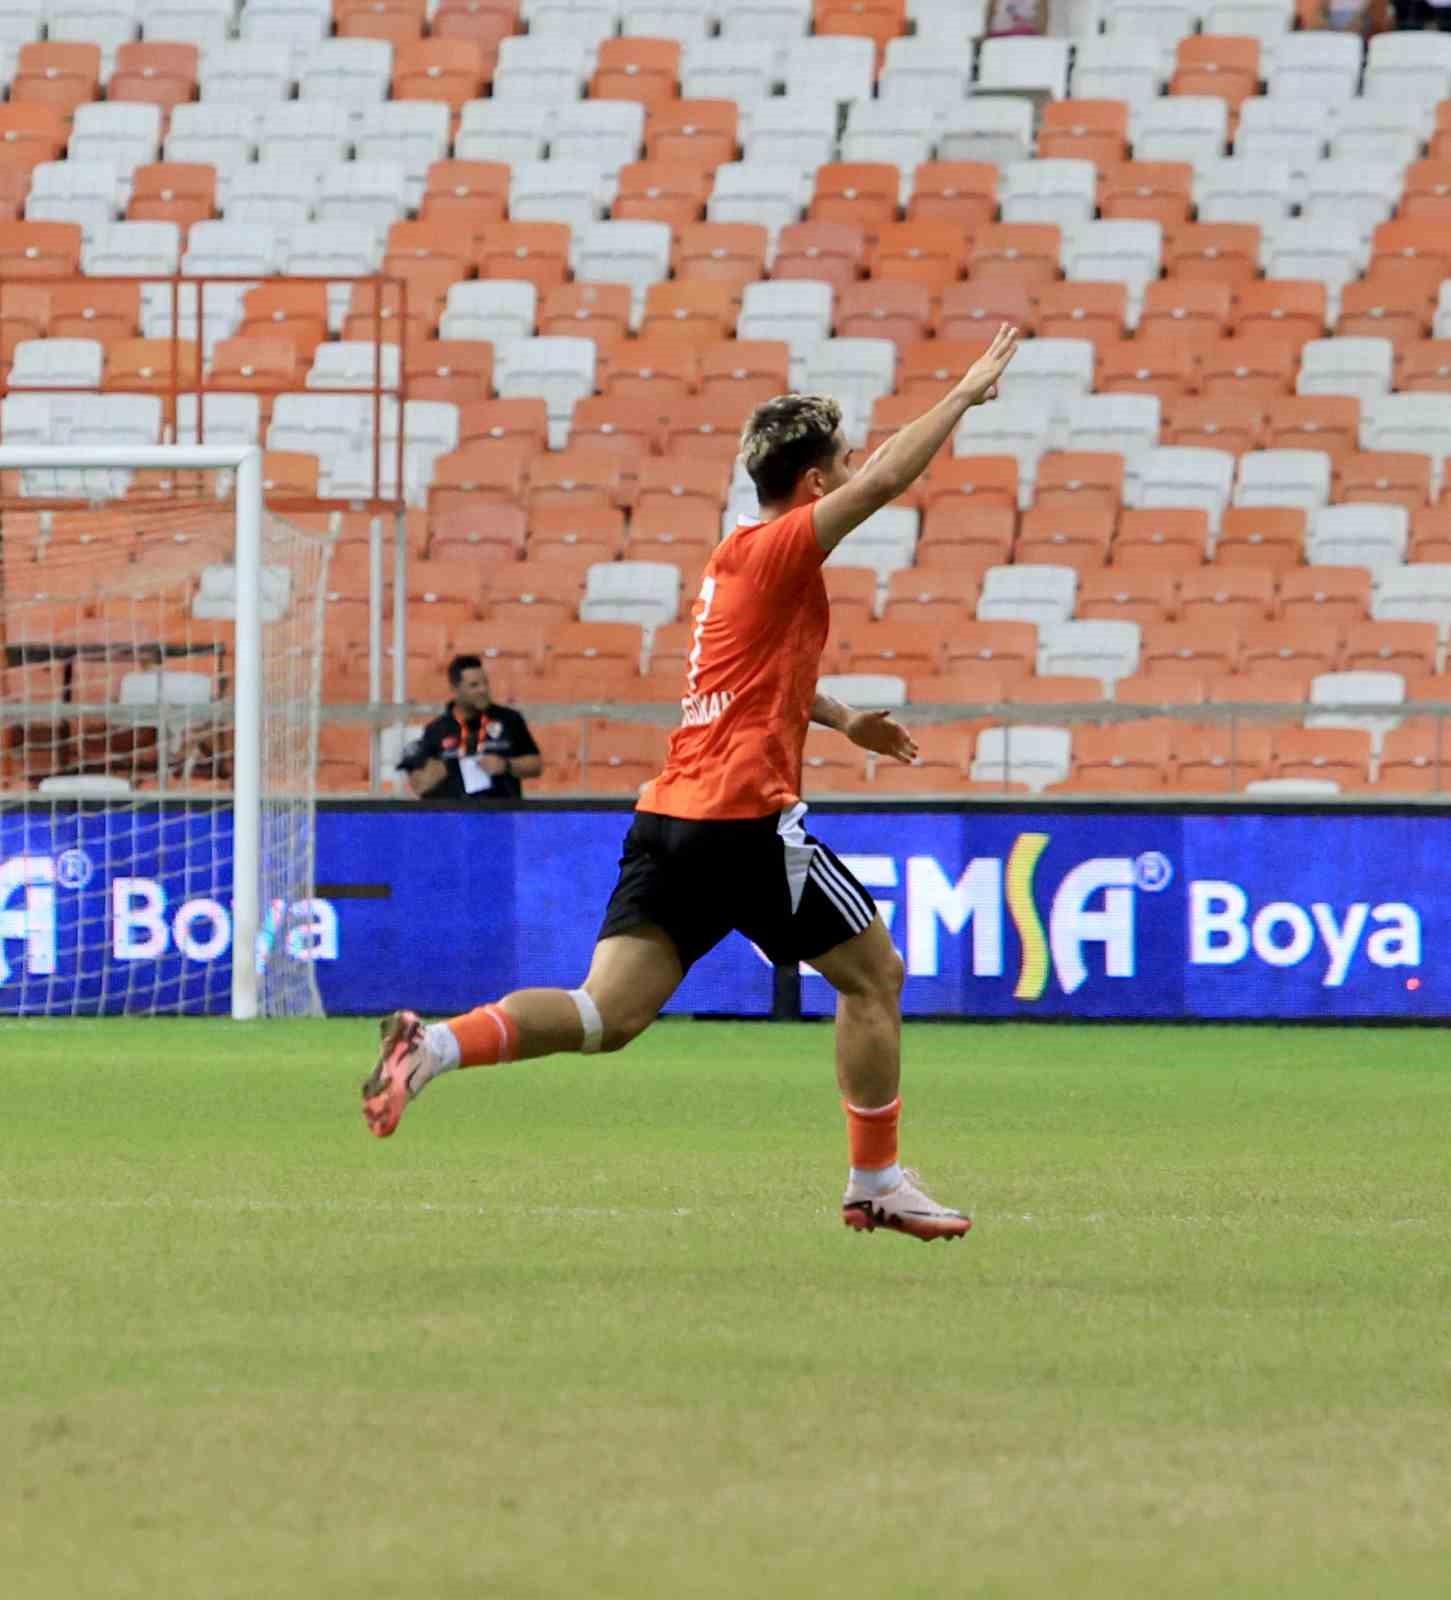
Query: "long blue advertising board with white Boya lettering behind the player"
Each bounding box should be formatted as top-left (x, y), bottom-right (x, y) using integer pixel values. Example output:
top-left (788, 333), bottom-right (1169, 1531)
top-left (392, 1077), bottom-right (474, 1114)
top-left (0, 797), bottom-right (1451, 1021)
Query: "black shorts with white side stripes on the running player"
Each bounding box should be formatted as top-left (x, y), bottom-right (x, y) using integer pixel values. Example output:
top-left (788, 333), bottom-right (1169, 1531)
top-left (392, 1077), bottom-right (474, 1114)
top-left (600, 805), bottom-right (877, 971)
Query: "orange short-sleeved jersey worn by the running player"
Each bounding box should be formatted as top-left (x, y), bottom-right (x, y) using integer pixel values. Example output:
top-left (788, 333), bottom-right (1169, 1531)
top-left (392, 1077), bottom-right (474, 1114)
top-left (640, 506), bottom-right (830, 819)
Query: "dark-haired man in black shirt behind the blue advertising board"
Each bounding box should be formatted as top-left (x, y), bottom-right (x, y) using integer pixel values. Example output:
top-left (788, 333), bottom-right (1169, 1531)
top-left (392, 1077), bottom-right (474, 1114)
top-left (398, 656), bottom-right (544, 800)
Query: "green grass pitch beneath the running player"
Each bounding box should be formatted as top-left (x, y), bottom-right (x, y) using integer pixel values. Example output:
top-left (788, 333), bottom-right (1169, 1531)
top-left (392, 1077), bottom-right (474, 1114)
top-left (0, 1021), bottom-right (1451, 1600)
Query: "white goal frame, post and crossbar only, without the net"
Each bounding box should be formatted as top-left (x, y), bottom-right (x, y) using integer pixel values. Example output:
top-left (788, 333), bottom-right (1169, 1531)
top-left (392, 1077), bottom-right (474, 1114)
top-left (0, 445), bottom-right (262, 1022)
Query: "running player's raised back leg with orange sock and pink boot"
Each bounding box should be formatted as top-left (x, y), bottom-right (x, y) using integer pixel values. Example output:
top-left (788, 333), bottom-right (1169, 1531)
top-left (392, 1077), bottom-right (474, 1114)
top-left (363, 925), bottom-right (685, 1138)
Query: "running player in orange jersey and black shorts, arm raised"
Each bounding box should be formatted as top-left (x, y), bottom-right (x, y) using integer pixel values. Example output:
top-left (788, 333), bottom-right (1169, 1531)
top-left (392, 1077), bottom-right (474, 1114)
top-left (363, 325), bottom-right (1017, 1240)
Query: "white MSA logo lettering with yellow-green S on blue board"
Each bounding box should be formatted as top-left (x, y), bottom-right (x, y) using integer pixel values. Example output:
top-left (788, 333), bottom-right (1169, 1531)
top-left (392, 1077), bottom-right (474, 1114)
top-left (841, 834), bottom-right (1173, 1000)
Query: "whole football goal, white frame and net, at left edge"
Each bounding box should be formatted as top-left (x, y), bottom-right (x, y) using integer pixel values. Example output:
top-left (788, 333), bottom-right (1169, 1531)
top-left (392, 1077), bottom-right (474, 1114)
top-left (0, 446), bottom-right (334, 1018)
